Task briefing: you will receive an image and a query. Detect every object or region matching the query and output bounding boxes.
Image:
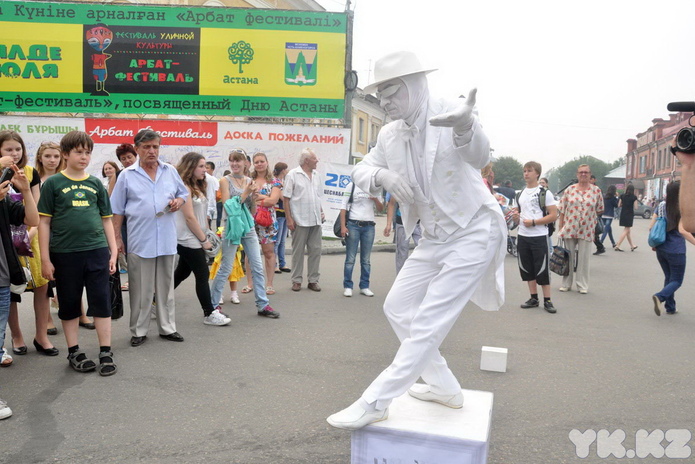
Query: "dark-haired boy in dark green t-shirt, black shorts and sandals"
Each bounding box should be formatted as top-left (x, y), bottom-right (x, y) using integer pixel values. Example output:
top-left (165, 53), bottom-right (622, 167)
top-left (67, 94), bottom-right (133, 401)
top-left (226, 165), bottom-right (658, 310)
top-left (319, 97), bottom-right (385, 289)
top-left (39, 131), bottom-right (118, 376)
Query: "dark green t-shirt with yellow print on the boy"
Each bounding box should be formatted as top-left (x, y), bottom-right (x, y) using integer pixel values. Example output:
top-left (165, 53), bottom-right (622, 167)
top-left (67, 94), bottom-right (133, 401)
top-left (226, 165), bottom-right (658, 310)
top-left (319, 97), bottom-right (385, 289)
top-left (38, 172), bottom-right (113, 253)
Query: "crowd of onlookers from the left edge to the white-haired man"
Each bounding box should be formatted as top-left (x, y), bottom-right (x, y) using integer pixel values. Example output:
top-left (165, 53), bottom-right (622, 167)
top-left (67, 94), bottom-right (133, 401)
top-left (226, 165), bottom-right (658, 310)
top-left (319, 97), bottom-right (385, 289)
top-left (0, 130), bottom-right (340, 419)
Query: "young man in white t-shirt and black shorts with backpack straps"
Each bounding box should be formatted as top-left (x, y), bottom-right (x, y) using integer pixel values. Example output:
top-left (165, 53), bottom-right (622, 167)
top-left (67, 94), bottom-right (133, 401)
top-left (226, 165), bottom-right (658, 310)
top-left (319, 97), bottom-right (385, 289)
top-left (514, 161), bottom-right (557, 314)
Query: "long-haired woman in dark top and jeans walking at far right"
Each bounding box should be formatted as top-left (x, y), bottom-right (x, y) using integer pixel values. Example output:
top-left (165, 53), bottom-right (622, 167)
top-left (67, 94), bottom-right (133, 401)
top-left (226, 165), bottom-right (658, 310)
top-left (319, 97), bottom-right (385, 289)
top-left (649, 181), bottom-right (695, 316)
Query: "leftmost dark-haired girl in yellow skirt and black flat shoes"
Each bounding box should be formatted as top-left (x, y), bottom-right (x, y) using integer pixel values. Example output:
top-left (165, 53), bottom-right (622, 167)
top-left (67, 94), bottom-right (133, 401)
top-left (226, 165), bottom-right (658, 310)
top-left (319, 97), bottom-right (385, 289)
top-left (0, 130), bottom-right (58, 356)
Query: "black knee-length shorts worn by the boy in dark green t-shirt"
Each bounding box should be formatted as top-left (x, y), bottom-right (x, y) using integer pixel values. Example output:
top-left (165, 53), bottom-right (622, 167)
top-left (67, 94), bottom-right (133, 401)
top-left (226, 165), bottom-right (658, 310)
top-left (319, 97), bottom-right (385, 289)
top-left (51, 248), bottom-right (111, 321)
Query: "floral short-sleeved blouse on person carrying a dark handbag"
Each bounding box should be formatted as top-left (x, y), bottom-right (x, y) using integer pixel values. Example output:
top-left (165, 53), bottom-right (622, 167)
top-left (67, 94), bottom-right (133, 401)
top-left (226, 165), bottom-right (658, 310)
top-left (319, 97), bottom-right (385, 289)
top-left (557, 184), bottom-right (603, 242)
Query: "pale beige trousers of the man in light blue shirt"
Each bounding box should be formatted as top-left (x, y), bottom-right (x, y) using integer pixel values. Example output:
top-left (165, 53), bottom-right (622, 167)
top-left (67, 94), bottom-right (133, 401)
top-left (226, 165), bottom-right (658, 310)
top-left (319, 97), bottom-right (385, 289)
top-left (128, 253), bottom-right (176, 337)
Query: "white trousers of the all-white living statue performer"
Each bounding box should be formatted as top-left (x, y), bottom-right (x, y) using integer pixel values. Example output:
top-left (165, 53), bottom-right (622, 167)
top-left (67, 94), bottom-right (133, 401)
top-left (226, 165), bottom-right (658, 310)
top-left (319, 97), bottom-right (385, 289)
top-left (362, 210), bottom-right (503, 409)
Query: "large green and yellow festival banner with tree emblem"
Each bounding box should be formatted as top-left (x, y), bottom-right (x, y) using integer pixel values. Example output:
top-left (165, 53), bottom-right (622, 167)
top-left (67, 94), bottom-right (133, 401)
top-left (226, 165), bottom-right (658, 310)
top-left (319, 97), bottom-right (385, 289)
top-left (0, 1), bottom-right (348, 119)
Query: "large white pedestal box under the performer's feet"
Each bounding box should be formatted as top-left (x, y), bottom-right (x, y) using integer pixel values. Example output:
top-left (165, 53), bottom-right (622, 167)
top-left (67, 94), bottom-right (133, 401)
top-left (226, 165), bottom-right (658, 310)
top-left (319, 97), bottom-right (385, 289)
top-left (350, 390), bottom-right (493, 464)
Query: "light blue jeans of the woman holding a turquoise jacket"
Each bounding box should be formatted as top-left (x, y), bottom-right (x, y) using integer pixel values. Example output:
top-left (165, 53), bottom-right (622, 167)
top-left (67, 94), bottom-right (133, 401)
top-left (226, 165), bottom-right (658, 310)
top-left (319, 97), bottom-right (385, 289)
top-left (210, 228), bottom-right (269, 311)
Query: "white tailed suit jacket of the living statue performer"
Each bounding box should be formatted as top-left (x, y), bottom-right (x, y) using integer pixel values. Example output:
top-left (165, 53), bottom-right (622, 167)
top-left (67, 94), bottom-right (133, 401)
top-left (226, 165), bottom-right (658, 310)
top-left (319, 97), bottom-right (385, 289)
top-left (352, 98), bottom-right (507, 310)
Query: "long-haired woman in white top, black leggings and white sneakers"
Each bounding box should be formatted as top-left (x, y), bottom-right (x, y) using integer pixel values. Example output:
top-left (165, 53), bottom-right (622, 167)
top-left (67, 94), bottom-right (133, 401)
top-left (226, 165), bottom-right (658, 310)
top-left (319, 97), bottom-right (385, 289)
top-left (174, 152), bottom-right (232, 325)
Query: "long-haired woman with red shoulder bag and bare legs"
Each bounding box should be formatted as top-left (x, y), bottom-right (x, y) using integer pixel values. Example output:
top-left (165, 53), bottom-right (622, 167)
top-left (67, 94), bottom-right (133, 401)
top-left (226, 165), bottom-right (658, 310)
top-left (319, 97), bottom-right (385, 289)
top-left (251, 152), bottom-right (282, 295)
